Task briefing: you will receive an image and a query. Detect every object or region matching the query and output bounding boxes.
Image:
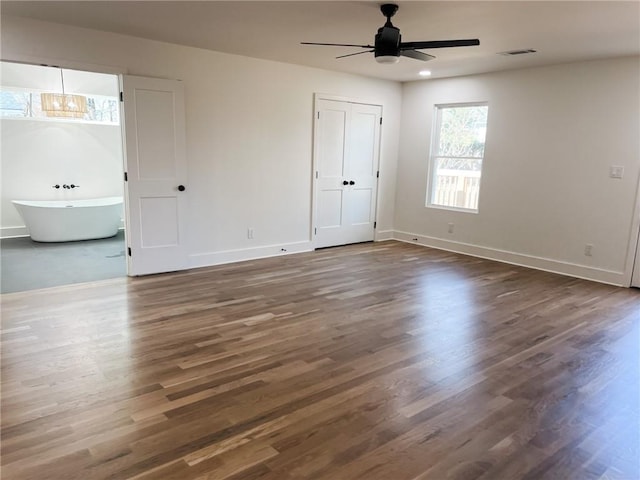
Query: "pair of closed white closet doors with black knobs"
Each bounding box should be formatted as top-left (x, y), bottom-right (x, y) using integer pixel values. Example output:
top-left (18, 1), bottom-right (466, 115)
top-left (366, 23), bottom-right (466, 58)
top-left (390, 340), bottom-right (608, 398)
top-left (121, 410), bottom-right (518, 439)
top-left (314, 99), bottom-right (382, 248)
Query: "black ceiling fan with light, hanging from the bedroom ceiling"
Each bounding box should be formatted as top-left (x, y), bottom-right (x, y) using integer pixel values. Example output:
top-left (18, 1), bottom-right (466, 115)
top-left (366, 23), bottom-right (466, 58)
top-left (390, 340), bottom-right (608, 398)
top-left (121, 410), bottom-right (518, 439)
top-left (301, 3), bottom-right (480, 63)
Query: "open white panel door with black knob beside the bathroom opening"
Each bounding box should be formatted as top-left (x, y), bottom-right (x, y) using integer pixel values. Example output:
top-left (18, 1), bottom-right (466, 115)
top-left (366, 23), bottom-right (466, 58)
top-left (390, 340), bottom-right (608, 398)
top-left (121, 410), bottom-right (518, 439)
top-left (121, 75), bottom-right (187, 275)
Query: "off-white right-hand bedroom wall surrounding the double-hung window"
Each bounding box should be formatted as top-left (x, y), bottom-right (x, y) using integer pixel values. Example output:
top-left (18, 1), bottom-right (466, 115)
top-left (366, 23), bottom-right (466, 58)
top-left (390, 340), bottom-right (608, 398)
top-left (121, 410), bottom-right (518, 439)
top-left (394, 57), bottom-right (640, 285)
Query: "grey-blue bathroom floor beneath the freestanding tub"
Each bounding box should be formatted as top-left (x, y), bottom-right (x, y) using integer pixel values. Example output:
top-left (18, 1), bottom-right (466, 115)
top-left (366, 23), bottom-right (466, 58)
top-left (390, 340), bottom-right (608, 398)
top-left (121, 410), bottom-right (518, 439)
top-left (0, 230), bottom-right (127, 293)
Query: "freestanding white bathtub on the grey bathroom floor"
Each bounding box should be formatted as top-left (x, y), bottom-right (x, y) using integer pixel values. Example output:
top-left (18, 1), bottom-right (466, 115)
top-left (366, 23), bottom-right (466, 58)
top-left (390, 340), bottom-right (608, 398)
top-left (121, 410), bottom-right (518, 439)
top-left (13, 197), bottom-right (122, 242)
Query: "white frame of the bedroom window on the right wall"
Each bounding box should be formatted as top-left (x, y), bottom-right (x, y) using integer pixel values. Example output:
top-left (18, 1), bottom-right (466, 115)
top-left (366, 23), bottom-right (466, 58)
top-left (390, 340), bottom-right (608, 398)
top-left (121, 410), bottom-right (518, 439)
top-left (425, 101), bottom-right (489, 213)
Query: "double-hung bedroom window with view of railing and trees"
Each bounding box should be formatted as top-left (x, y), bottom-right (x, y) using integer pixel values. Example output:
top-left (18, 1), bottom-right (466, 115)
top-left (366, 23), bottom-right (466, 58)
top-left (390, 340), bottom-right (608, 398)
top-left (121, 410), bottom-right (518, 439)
top-left (427, 103), bottom-right (489, 212)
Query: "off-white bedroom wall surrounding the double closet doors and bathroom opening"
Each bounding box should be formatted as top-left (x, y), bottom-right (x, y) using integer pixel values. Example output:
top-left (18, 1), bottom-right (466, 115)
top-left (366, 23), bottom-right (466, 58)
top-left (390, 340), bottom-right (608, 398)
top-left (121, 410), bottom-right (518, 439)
top-left (2, 16), bottom-right (402, 266)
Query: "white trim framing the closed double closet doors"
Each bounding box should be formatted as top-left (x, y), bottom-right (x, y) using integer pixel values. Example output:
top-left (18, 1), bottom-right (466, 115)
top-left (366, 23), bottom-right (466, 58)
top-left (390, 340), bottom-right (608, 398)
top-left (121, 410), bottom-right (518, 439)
top-left (310, 93), bottom-right (384, 249)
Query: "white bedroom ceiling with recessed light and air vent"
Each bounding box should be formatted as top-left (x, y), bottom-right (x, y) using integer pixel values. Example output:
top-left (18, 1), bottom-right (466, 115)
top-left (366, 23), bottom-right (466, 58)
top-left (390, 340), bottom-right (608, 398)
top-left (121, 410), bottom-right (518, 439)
top-left (2, 0), bottom-right (640, 81)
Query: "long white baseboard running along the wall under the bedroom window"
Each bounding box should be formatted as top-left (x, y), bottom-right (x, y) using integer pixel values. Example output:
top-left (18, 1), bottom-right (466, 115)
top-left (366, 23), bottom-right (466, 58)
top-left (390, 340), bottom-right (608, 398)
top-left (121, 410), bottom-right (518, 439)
top-left (393, 230), bottom-right (629, 287)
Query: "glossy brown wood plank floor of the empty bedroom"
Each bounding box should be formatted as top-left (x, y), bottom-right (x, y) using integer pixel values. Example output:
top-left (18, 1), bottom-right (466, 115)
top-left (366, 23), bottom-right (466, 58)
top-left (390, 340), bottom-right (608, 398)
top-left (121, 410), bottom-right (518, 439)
top-left (1, 242), bottom-right (640, 480)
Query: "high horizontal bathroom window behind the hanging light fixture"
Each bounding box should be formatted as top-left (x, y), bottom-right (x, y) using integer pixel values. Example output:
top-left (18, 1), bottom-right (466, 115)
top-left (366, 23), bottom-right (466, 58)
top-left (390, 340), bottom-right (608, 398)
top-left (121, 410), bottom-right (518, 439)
top-left (0, 87), bottom-right (120, 125)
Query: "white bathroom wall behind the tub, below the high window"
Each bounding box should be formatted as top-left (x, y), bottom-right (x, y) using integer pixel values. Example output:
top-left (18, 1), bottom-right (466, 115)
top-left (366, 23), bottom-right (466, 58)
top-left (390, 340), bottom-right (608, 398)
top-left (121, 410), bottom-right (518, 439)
top-left (0, 118), bottom-right (123, 237)
